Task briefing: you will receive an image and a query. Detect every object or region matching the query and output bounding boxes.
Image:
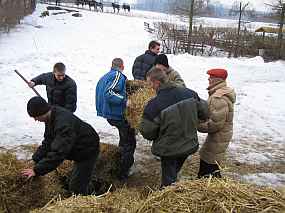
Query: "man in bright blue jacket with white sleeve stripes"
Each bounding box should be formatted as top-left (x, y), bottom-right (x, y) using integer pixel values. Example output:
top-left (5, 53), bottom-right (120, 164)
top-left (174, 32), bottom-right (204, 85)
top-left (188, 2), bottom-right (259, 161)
top-left (96, 58), bottom-right (136, 181)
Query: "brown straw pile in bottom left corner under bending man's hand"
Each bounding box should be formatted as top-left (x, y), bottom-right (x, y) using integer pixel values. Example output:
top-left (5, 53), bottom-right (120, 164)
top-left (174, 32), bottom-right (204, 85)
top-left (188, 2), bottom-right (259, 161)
top-left (0, 152), bottom-right (64, 212)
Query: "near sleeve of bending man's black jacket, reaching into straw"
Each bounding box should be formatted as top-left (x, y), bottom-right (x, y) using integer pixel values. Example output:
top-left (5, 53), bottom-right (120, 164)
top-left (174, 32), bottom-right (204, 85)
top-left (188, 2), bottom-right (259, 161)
top-left (34, 125), bottom-right (76, 175)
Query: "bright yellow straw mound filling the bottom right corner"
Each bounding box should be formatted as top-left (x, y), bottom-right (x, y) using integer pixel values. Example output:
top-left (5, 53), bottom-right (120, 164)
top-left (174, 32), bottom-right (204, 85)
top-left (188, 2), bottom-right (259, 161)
top-left (136, 179), bottom-right (285, 213)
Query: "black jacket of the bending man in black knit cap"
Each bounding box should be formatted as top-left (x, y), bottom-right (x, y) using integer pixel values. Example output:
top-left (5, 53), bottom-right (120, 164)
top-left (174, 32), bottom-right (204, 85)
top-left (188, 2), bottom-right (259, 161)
top-left (33, 107), bottom-right (99, 175)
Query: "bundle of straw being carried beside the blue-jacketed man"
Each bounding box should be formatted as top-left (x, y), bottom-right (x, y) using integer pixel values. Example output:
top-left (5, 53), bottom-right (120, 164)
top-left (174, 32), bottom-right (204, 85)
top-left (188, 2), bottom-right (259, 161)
top-left (126, 80), bottom-right (155, 130)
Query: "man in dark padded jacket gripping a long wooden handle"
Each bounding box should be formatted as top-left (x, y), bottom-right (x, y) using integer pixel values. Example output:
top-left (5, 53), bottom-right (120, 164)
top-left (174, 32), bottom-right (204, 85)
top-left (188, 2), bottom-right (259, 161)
top-left (29, 63), bottom-right (77, 112)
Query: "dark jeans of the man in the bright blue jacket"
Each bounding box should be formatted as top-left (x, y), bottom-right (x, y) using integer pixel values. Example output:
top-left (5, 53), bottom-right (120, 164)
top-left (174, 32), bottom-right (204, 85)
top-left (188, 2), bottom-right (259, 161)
top-left (108, 119), bottom-right (136, 179)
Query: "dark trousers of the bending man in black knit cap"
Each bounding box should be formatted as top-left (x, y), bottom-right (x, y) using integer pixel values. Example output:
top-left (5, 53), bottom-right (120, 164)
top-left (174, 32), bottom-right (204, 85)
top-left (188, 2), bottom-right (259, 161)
top-left (69, 154), bottom-right (98, 195)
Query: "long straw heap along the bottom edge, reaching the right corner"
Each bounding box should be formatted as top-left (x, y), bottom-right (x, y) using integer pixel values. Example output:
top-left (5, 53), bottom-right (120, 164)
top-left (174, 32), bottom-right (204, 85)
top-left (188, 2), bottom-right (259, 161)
top-left (31, 179), bottom-right (285, 213)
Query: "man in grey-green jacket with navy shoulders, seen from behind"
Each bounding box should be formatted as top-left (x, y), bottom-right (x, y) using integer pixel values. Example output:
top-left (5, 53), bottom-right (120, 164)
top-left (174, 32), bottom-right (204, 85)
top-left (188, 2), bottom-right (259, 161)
top-left (140, 68), bottom-right (207, 187)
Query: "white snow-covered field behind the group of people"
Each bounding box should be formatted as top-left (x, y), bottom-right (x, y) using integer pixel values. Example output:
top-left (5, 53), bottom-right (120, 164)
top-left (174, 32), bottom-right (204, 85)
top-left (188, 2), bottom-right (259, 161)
top-left (0, 5), bottom-right (285, 185)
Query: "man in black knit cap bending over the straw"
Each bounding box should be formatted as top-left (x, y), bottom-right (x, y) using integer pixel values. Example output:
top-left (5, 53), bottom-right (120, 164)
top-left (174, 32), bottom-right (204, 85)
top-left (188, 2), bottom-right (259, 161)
top-left (21, 97), bottom-right (99, 195)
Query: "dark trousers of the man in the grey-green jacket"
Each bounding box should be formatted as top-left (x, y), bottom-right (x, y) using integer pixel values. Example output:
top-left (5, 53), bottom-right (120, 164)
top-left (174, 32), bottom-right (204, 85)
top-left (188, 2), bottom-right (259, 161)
top-left (161, 155), bottom-right (188, 187)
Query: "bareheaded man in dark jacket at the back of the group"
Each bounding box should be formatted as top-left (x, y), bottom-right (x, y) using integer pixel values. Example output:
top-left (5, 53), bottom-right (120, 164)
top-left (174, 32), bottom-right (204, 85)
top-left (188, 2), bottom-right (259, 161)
top-left (132, 41), bottom-right (160, 80)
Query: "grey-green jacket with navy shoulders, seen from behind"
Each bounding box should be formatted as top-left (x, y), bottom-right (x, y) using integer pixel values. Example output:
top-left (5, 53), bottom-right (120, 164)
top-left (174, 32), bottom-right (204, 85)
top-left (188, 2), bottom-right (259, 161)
top-left (141, 83), bottom-right (206, 156)
